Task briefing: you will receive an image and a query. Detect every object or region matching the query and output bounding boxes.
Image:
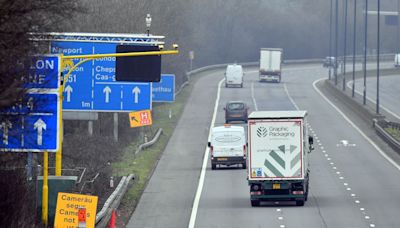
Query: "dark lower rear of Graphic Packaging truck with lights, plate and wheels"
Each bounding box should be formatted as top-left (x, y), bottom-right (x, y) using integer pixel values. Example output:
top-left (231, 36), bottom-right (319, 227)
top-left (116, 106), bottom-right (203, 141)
top-left (249, 178), bottom-right (308, 206)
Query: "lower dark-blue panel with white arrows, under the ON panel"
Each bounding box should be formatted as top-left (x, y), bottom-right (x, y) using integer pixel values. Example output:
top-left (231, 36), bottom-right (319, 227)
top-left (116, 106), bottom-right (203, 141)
top-left (0, 93), bottom-right (60, 152)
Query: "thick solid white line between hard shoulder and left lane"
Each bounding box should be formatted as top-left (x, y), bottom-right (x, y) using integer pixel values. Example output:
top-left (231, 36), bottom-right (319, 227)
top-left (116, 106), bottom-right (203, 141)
top-left (188, 79), bottom-right (225, 228)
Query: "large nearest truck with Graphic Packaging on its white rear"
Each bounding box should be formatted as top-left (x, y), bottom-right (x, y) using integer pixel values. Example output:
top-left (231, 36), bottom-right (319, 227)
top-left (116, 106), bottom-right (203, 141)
top-left (247, 111), bottom-right (313, 207)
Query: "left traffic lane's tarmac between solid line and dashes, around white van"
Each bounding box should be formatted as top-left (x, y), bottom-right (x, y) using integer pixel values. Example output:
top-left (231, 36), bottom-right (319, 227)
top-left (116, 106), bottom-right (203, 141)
top-left (195, 70), bottom-right (280, 228)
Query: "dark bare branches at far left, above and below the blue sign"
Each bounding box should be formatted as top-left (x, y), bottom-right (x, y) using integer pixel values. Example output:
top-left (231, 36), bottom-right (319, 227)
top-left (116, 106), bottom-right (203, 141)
top-left (0, 0), bottom-right (81, 227)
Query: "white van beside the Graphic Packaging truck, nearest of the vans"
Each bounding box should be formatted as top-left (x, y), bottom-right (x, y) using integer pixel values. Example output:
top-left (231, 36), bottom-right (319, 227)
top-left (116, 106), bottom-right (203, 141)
top-left (208, 124), bottom-right (247, 169)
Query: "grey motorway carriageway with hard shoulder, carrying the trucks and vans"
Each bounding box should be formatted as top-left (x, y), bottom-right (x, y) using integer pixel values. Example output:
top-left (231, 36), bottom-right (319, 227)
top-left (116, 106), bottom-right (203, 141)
top-left (127, 64), bottom-right (400, 228)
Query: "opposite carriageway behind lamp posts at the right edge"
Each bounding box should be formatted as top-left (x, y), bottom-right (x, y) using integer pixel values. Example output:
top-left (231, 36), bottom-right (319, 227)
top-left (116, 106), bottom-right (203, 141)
top-left (354, 75), bottom-right (400, 120)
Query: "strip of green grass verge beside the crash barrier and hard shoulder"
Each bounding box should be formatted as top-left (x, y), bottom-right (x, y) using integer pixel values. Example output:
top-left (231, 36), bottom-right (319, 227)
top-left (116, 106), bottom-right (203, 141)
top-left (112, 81), bottom-right (192, 227)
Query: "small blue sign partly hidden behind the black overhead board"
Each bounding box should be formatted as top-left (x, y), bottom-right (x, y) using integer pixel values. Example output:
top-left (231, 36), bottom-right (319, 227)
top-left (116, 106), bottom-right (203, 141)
top-left (151, 74), bottom-right (175, 102)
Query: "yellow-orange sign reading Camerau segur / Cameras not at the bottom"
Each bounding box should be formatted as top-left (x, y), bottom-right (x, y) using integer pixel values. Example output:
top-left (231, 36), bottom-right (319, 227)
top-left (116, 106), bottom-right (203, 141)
top-left (54, 192), bottom-right (97, 228)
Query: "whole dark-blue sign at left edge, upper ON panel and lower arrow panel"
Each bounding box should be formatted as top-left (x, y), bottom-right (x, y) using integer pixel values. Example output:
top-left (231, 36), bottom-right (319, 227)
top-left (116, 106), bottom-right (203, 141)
top-left (0, 56), bottom-right (61, 152)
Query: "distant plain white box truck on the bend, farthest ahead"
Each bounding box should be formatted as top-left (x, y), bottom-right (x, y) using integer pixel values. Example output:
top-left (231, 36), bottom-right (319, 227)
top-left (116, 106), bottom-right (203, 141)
top-left (259, 48), bottom-right (283, 83)
